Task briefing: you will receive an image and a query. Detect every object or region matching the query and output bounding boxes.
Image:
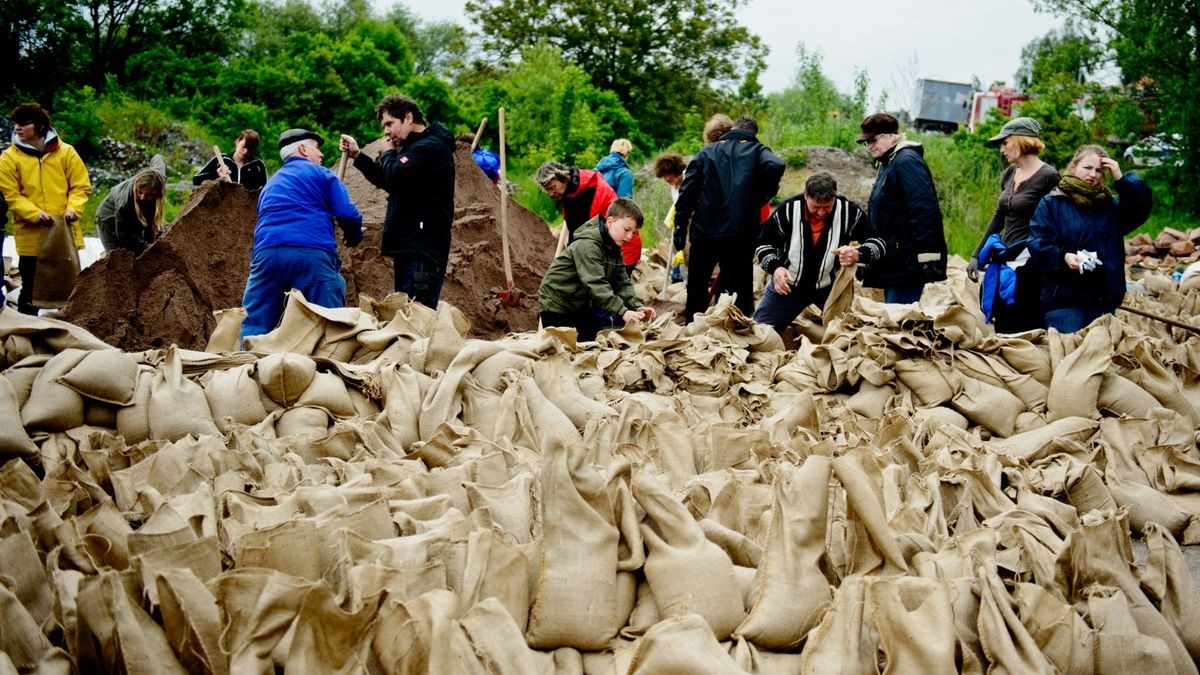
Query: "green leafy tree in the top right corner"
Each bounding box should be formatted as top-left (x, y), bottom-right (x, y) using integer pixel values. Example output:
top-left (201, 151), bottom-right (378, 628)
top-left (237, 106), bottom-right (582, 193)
top-left (1036, 0), bottom-right (1200, 213)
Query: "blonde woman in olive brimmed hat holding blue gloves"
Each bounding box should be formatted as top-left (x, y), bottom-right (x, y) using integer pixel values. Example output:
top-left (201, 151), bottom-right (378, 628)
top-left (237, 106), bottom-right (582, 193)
top-left (967, 118), bottom-right (1058, 333)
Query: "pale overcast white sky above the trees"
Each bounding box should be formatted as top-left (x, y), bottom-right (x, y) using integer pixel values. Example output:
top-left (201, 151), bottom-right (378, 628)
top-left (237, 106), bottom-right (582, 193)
top-left (398, 0), bottom-right (1062, 108)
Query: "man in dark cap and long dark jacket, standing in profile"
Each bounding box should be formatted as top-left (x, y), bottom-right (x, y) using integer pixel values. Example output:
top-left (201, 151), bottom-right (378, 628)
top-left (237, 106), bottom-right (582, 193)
top-left (838, 113), bottom-right (946, 304)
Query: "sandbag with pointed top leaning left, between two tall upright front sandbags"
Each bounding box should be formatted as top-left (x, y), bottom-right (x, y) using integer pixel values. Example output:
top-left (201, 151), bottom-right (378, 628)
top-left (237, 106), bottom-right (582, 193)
top-left (632, 471), bottom-right (745, 640)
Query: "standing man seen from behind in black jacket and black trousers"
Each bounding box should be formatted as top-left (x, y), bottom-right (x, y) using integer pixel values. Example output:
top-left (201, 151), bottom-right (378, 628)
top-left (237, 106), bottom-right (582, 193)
top-left (674, 117), bottom-right (784, 319)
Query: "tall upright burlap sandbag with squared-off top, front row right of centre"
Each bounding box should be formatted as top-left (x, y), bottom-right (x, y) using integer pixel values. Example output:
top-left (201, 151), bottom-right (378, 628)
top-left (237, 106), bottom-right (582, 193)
top-left (736, 455), bottom-right (833, 650)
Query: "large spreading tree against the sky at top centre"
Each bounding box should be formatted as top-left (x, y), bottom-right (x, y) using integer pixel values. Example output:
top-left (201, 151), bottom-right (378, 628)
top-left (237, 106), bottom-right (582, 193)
top-left (467, 0), bottom-right (767, 144)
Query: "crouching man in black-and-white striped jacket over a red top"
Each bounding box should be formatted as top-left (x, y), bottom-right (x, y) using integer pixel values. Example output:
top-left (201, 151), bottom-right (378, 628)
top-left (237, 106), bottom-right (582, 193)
top-left (754, 172), bottom-right (865, 333)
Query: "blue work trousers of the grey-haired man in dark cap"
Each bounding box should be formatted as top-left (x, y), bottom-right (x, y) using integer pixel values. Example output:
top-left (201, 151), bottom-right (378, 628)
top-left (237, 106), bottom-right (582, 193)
top-left (241, 246), bottom-right (346, 338)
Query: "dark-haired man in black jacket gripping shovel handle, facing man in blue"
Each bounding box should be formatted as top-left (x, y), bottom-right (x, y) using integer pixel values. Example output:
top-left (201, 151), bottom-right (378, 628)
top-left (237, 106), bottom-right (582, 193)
top-left (342, 94), bottom-right (455, 307)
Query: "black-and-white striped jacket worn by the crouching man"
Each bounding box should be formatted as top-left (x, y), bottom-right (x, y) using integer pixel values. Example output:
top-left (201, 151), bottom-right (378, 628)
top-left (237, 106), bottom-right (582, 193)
top-left (755, 193), bottom-right (864, 288)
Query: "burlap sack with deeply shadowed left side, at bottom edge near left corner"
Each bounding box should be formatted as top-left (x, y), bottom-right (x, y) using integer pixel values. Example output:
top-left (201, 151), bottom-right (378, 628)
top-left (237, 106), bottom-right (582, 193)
top-left (74, 572), bottom-right (187, 675)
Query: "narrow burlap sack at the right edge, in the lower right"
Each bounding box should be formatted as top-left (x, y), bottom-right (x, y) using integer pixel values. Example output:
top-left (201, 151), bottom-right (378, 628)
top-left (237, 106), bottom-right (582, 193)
top-left (1141, 522), bottom-right (1200, 662)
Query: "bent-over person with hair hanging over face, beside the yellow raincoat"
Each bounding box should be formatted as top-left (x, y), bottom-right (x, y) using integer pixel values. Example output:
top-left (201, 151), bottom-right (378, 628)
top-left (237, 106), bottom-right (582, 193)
top-left (96, 155), bottom-right (167, 255)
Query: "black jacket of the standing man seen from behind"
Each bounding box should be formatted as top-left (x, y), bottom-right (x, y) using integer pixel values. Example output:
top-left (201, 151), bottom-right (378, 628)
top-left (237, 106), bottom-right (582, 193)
top-left (674, 129), bottom-right (784, 242)
